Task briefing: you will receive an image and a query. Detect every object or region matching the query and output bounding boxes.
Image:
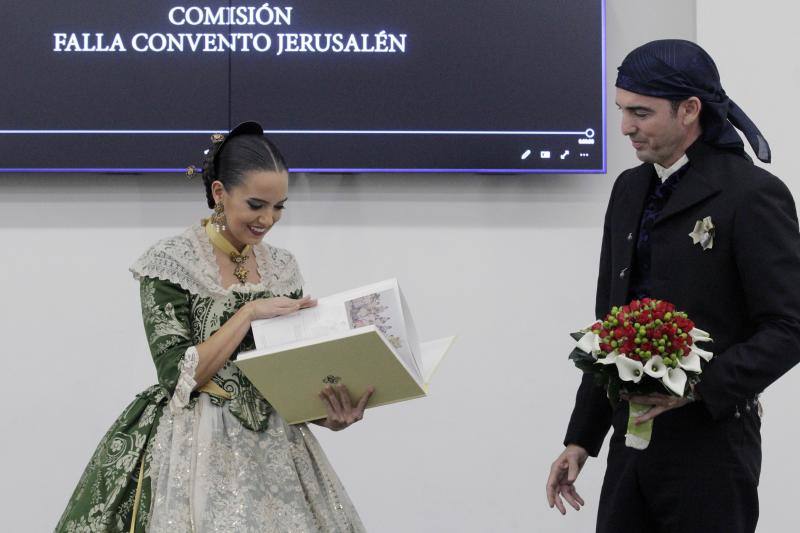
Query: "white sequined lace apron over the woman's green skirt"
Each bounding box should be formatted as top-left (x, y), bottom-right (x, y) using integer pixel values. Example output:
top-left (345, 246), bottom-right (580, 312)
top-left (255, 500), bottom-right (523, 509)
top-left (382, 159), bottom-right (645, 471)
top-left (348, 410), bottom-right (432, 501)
top-left (148, 393), bottom-right (364, 533)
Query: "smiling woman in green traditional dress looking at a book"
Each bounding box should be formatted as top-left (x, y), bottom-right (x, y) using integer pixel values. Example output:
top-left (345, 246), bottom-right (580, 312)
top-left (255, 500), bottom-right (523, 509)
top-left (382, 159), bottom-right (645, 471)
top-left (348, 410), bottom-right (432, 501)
top-left (56, 122), bottom-right (372, 533)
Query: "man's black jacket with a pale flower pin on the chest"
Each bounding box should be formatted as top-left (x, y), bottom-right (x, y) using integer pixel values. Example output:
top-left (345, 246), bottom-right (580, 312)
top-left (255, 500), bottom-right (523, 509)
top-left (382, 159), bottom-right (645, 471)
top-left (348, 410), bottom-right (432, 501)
top-left (565, 141), bottom-right (800, 456)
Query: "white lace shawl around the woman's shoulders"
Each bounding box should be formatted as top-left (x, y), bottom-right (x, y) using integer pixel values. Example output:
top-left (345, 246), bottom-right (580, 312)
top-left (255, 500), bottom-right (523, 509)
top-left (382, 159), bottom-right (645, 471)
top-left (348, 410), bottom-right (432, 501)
top-left (130, 224), bottom-right (303, 297)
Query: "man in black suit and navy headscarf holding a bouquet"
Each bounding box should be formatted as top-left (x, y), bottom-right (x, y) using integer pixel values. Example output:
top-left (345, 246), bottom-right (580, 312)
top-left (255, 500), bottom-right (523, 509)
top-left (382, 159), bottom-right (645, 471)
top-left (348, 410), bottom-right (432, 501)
top-left (547, 40), bottom-right (800, 533)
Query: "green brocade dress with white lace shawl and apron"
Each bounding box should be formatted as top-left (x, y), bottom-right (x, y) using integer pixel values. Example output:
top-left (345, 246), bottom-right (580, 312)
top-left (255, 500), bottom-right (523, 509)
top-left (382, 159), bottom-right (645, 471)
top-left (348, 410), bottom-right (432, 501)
top-left (56, 225), bottom-right (363, 533)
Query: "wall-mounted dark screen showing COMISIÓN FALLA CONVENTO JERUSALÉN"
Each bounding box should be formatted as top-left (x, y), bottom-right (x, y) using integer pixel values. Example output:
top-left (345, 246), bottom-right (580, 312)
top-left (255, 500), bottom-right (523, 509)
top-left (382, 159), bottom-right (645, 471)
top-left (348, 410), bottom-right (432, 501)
top-left (0, 0), bottom-right (605, 173)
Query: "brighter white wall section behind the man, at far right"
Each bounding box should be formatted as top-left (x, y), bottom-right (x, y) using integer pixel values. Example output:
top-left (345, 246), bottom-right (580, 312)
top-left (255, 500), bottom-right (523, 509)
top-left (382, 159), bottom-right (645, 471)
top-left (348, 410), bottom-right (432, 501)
top-left (697, 0), bottom-right (800, 533)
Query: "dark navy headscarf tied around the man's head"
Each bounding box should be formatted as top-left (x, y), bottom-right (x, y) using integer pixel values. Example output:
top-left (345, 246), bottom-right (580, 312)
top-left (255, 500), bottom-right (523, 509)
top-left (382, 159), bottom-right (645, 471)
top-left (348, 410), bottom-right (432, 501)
top-left (617, 39), bottom-right (772, 163)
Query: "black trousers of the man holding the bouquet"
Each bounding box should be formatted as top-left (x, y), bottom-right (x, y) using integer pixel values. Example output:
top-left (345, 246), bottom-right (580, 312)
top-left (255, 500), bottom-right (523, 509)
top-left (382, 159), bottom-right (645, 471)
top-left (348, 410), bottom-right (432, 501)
top-left (597, 403), bottom-right (761, 533)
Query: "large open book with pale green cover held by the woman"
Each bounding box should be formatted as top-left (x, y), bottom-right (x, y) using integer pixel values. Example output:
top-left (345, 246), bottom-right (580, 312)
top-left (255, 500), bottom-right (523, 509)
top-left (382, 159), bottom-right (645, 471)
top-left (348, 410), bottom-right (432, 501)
top-left (236, 279), bottom-right (455, 424)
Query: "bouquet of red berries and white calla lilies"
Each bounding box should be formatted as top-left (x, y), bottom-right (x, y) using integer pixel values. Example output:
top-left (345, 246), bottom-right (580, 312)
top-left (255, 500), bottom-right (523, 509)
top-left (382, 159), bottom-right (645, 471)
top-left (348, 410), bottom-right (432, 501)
top-left (569, 298), bottom-right (713, 449)
